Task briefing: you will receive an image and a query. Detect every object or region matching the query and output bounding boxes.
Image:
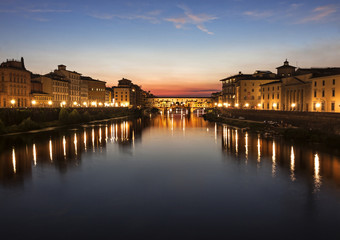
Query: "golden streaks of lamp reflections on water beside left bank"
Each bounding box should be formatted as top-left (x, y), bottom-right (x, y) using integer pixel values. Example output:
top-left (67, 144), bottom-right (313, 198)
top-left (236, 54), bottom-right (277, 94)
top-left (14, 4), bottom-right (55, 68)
top-left (0, 119), bottom-right (150, 185)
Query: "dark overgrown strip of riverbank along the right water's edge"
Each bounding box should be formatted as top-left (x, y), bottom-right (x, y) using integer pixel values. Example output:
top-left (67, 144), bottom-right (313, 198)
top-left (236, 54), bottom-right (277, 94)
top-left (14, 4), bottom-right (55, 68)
top-left (203, 109), bottom-right (340, 148)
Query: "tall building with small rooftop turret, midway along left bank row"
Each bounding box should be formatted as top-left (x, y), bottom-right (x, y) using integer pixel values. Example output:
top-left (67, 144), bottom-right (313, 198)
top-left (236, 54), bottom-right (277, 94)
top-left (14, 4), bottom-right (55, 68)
top-left (54, 64), bottom-right (81, 106)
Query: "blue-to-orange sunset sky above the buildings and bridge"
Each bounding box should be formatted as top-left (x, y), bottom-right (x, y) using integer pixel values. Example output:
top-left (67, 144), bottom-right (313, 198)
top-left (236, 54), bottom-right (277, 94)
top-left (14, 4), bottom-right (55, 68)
top-left (0, 0), bottom-right (340, 96)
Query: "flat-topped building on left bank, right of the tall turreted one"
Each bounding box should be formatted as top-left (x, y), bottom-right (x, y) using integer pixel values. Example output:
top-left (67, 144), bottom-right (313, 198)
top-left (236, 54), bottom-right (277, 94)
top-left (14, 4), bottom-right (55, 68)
top-left (80, 76), bottom-right (106, 107)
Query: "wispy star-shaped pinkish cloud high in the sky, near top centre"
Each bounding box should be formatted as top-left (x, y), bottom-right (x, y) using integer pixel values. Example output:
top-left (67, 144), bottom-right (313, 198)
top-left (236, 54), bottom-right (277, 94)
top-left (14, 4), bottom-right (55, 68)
top-left (164, 5), bottom-right (217, 35)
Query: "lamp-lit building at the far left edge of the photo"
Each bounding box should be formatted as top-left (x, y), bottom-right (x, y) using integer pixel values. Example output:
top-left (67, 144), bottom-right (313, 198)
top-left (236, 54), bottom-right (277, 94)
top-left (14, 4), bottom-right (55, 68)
top-left (0, 58), bottom-right (31, 107)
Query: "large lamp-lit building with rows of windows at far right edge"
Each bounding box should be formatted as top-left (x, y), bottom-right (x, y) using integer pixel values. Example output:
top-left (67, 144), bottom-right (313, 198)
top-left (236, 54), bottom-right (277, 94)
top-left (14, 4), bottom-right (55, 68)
top-left (261, 65), bottom-right (340, 112)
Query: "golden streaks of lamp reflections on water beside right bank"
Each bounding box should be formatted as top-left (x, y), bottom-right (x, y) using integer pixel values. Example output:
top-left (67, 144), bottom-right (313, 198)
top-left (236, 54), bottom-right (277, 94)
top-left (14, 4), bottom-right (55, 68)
top-left (220, 126), bottom-right (340, 192)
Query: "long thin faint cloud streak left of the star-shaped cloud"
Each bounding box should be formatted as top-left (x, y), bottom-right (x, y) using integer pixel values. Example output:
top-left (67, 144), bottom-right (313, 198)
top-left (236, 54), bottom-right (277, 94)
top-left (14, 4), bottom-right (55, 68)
top-left (90, 10), bottom-right (161, 24)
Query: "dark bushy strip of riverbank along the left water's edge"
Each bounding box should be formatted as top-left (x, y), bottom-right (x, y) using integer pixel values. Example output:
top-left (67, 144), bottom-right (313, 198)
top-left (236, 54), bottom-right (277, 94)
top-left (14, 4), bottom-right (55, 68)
top-left (0, 108), bottom-right (142, 134)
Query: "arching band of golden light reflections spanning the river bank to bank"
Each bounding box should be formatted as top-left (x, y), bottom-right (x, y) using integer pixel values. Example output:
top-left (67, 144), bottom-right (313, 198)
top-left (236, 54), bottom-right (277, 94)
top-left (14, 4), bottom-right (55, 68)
top-left (0, 111), bottom-right (340, 192)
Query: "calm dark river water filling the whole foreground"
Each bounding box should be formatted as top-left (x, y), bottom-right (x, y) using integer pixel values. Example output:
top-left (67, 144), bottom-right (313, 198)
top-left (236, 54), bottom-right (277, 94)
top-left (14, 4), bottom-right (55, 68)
top-left (0, 114), bottom-right (340, 239)
